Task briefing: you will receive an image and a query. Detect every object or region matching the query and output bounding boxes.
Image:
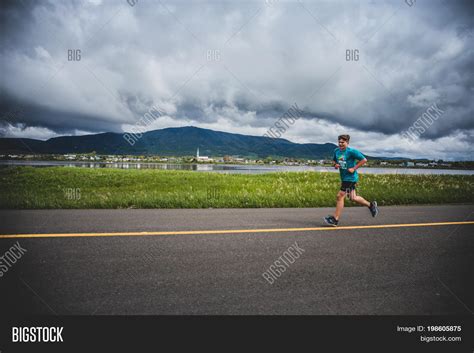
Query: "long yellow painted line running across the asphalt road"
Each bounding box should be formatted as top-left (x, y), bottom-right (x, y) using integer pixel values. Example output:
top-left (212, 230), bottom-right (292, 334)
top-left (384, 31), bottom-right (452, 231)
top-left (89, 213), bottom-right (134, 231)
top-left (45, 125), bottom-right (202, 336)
top-left (0, 221), bottom-right (474, 239)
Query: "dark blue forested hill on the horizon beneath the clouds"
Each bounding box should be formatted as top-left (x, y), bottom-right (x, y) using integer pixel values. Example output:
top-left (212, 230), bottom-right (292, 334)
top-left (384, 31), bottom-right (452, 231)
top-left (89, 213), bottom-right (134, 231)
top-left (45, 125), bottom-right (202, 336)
top-left (0, 126), bottom-right (337, 159)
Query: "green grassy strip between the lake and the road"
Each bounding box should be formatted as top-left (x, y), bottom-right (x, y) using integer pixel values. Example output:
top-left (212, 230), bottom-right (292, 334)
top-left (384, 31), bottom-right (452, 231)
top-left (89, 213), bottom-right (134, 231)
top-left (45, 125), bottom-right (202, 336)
top-left (0, 167), bottom-right (474, 209)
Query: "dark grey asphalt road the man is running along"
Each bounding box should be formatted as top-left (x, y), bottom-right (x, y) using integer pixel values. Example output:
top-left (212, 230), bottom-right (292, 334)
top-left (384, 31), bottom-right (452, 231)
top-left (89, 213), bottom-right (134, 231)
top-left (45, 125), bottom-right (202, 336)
top-left (0, 205), bottom-right (474, 315)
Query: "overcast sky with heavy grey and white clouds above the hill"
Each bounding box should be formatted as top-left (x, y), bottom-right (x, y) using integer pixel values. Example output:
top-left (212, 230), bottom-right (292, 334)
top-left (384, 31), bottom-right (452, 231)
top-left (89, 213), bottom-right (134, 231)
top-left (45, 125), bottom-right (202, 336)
top-left (0, 0), bottom-right (474, 160)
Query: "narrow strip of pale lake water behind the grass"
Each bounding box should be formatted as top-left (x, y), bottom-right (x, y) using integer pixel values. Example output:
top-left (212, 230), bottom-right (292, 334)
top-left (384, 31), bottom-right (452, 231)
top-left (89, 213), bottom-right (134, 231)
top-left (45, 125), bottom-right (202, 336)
top-left (0, 160), bottom-right (474, 175)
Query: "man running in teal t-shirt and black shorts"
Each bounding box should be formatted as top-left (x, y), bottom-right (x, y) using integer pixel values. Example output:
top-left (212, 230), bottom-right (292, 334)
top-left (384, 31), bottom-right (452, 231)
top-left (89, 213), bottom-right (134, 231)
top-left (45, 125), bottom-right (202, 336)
top-left (324, 135), bottom-right (379, 227)
